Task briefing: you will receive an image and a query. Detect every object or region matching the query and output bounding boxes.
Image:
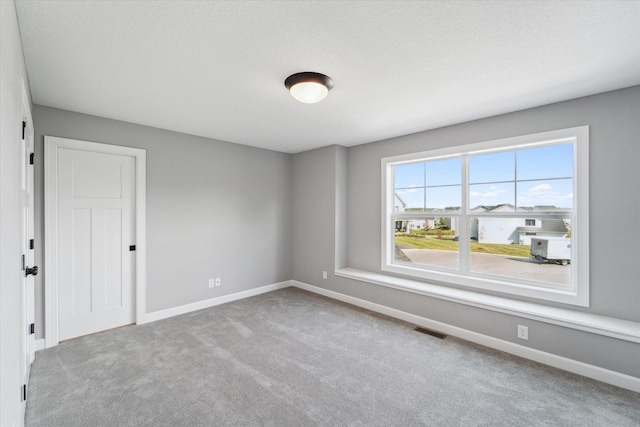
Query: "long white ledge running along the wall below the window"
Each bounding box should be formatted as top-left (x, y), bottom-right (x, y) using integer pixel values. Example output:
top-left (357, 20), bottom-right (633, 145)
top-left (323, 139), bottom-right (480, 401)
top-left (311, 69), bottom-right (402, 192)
top-left (335, 268), bottom-right (640, 343)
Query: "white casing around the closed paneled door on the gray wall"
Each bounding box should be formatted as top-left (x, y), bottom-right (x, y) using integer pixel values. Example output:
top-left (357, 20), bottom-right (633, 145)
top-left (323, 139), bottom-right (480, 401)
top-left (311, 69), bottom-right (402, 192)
top-left (44, 136), bottom-right (147, 348)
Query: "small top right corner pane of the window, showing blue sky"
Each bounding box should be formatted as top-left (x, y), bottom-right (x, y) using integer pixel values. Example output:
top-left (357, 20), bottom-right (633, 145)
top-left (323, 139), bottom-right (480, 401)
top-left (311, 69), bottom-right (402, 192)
top-left (516, 144), bottom-right (573, 180)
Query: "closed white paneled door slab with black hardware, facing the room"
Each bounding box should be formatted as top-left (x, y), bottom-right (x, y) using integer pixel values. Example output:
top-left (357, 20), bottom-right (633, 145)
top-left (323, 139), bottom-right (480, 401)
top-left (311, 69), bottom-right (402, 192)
top-left (57, 144), bottom-right (136, 341)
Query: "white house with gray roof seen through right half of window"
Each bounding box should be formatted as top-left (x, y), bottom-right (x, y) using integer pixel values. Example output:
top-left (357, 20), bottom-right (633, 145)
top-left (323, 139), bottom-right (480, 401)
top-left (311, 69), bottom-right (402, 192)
top-left (471, 204), bottom-right (569, 245)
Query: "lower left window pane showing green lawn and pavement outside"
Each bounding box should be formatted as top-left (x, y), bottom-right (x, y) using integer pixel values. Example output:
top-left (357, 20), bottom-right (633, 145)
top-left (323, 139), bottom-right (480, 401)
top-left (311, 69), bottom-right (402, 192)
top-left (394, 216), bottom-right (458, 269)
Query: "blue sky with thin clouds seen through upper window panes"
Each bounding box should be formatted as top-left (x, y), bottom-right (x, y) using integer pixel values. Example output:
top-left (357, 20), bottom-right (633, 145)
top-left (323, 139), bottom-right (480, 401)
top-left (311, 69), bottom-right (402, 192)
top-left (394, 144), bottom-right (573, 209)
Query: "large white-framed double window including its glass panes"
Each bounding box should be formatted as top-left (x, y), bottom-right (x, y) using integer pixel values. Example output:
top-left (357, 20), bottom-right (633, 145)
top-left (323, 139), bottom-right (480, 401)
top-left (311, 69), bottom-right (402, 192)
top-left (382, 126), bottom-right (589, 306)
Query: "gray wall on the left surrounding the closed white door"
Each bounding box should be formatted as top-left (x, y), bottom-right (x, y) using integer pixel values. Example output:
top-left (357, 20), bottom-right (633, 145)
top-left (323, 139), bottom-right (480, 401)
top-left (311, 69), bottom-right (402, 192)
top-left (34, 105), bottom-right (292, 337)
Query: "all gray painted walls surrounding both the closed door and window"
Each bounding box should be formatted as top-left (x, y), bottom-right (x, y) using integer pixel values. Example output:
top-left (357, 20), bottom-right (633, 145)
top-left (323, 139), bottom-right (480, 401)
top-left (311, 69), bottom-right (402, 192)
top-left (34, 87), bottom-right (640, 377)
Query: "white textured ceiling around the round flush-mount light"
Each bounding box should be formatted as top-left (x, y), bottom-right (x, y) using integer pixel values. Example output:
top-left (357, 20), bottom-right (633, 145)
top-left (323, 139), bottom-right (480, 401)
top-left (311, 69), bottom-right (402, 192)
top-left (16, 0), bottom-right (640, 153)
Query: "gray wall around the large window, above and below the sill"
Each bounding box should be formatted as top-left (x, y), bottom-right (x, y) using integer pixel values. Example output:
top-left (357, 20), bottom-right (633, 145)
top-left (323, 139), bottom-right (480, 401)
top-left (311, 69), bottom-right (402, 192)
top-left (293, 87), bottom-right (640, 377)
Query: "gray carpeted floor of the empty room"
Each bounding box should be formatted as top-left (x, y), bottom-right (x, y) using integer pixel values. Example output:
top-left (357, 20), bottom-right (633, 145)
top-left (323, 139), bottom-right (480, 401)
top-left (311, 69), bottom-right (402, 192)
top-left (26, 288), bottom-right (640, 427)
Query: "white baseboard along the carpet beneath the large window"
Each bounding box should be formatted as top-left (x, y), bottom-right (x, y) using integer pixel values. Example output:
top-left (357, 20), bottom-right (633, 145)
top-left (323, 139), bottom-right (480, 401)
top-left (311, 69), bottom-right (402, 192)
top-left (292, 280), bottom-right (640, 392)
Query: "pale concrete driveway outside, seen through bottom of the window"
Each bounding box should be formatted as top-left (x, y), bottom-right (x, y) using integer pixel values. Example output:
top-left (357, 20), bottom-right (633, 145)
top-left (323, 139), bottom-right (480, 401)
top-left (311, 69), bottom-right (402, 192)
top-left (396, 249), bottom-right (571, 285)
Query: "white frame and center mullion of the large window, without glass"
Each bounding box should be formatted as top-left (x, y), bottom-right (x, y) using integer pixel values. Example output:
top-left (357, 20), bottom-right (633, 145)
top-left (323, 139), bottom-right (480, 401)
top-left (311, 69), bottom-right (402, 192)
top-left (381, 126), bottom-right (589, 307)
